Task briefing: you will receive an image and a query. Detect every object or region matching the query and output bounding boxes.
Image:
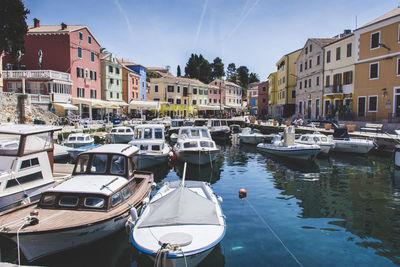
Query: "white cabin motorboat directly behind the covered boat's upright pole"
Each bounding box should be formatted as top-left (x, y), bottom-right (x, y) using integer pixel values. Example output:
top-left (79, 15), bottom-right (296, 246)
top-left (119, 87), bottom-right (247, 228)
top-left (174, 126), bottom-right (219, 165)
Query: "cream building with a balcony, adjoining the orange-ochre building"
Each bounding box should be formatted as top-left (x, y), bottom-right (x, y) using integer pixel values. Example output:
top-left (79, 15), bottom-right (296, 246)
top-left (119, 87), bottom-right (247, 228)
top-left (322, 33), bottom-right (355, 120)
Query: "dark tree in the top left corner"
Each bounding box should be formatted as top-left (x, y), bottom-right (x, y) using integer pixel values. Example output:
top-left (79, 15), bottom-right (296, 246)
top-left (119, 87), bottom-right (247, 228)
top-left (0, 0), bottom-right (30, 56)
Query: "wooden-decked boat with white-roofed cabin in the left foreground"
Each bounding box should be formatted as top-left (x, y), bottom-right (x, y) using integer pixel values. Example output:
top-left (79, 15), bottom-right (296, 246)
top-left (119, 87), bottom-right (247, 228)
top-left (0, 144), bottom-right (153, 261)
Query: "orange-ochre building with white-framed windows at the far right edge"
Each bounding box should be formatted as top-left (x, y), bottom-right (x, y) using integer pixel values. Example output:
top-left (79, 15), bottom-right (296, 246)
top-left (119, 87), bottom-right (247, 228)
top-left (353, 8), bottom-right (400, 121)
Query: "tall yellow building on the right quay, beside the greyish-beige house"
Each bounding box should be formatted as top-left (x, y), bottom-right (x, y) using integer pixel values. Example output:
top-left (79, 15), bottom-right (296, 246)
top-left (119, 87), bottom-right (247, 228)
top-left (276, 49), bottom-right (302, 118)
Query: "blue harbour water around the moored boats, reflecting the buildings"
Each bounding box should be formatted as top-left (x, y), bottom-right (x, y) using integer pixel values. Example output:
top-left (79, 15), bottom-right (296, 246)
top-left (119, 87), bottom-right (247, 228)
top-left (5, 137), bottom-right (400, 266)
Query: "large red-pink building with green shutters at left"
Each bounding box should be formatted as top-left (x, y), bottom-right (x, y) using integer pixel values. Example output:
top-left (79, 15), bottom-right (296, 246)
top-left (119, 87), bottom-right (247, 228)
top-left (4, 20), bottom-right (101, 99)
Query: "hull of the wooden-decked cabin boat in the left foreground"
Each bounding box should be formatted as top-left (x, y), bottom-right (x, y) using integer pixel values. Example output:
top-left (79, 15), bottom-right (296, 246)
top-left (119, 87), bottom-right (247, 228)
top-left (5, 212), bottom-right (129, 262)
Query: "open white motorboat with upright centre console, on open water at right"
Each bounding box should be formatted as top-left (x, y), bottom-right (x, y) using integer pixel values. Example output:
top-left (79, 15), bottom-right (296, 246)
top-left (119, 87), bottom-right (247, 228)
top-left (257, 126), bottom-right (321, 161)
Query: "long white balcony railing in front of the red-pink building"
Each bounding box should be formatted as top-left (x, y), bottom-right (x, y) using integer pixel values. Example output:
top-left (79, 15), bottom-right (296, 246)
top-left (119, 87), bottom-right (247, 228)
top-left (3, 70), bottom-right (71, 82)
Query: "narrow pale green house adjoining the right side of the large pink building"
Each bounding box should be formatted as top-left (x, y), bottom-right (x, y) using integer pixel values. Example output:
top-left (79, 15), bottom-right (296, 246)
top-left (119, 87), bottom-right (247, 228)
top-left (101, 53), bottom-right (123, 101)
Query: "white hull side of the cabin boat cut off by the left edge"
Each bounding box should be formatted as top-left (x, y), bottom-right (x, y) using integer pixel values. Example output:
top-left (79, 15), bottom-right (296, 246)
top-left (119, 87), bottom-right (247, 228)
top-left (0, 181), bottom-right (54, 211)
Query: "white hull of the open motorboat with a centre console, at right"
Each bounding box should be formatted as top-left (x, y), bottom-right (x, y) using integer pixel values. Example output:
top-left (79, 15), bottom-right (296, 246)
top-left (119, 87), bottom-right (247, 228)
top-left (257, 145), bottom-right (321, 161)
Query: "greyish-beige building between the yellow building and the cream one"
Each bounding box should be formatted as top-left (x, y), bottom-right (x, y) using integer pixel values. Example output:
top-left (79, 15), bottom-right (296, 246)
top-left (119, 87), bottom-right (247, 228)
top-left (296, 38), bottom-right (335, 119)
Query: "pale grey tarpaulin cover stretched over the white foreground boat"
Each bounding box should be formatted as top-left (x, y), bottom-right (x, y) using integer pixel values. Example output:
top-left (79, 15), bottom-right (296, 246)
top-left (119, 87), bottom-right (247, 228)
top-left (138, 186), bottom-right (220, 228)
